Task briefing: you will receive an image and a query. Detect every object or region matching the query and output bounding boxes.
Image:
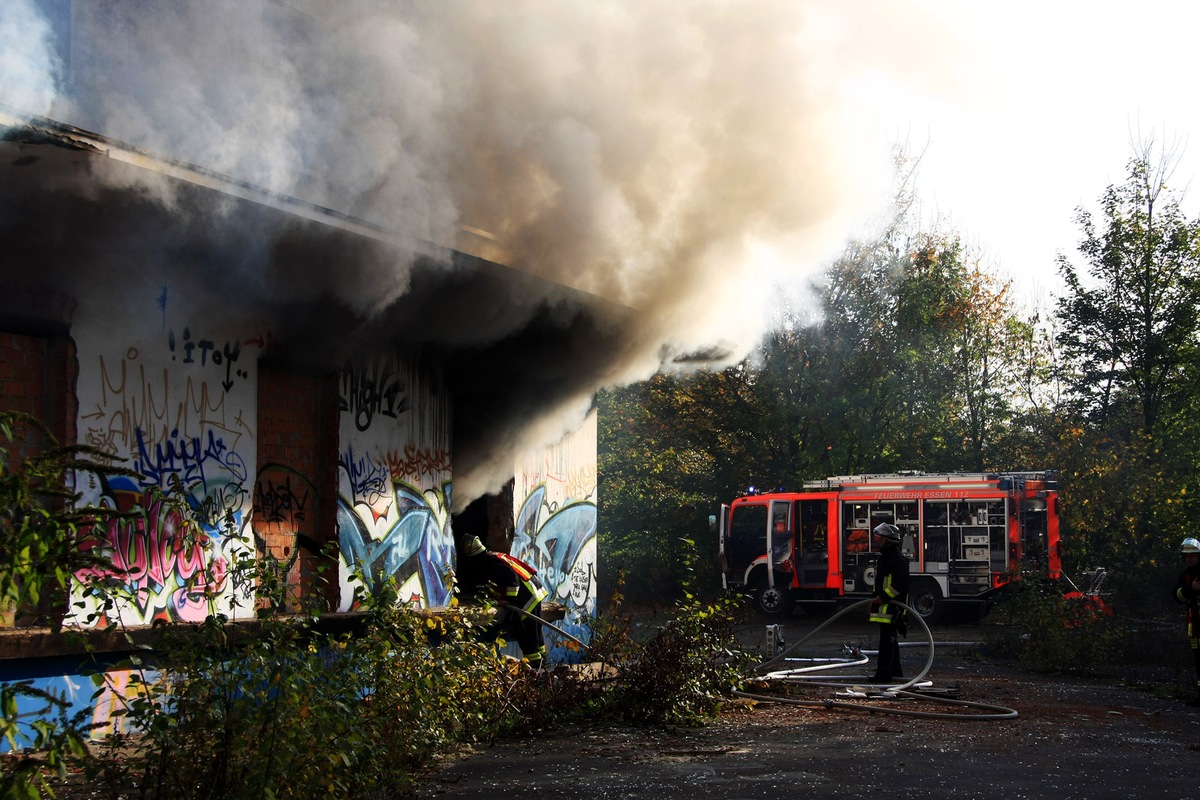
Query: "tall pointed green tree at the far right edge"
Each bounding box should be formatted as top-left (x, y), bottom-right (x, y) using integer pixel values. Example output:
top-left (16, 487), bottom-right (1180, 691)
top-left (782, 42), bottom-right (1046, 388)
top-left (1056, 145), bottom-right (1200, 612)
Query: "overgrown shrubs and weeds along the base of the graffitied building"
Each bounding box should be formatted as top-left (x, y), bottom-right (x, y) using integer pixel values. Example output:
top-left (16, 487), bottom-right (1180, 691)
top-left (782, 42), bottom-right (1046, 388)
top-left (0, 417), bottom-right (753, 800)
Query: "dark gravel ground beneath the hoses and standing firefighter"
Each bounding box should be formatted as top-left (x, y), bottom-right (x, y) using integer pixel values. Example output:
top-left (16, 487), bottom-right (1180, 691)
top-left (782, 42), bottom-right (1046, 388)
top-left (416, 620), bottom-right (1200, 800)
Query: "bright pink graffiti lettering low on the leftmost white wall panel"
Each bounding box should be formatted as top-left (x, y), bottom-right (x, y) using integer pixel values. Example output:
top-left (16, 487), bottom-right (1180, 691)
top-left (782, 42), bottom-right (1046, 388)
top-left (76, 494), bottom-right (229, 621)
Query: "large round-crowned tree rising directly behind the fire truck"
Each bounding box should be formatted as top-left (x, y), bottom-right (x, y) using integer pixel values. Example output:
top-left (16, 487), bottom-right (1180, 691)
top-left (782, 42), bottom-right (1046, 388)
top-left (739, 227), bottom-right (1031, 486)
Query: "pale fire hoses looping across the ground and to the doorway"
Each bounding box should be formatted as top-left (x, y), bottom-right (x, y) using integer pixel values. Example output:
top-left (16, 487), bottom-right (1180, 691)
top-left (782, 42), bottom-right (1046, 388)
top-left (504, 599), bottom-right (1019, 722)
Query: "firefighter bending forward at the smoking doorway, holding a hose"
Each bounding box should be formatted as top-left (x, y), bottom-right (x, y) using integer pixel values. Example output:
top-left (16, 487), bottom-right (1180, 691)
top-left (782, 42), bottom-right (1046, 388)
top-left (461, 536), bottom-right (548, 669)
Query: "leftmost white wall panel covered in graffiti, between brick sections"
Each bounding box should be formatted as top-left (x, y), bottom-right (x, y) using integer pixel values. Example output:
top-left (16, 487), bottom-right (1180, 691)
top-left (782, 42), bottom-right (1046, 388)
top-left (74, 325), bottom-right (270, 625)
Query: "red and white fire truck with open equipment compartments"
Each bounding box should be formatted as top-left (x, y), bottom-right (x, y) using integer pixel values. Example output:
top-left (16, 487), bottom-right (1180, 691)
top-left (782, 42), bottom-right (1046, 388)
top-left (713, 471), bottom-right (1061, 622)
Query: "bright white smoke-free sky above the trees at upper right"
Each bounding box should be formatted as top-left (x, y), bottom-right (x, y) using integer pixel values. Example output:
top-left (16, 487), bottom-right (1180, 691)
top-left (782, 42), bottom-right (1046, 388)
top-left (881, 0), bottom-right (1200, 302)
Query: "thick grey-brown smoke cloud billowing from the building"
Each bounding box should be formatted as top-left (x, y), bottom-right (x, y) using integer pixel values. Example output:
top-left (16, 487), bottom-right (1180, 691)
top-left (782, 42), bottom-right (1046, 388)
top-left (0, 0), bottom-right (979, 495)
